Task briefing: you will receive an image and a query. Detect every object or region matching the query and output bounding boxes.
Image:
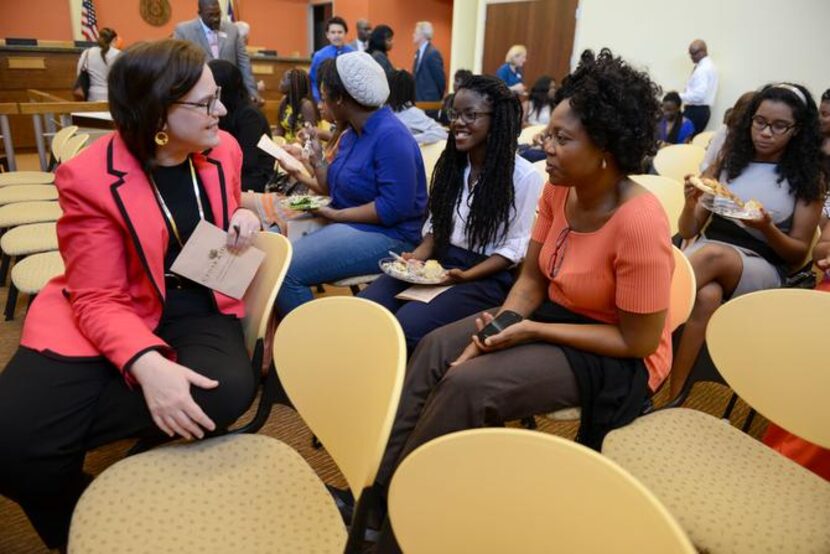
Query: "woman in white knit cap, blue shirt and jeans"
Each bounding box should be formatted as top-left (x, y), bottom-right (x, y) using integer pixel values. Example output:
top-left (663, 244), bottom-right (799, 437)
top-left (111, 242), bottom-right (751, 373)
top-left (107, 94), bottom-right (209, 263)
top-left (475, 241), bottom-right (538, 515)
top-left (277, 52), bottom-right (427, 317)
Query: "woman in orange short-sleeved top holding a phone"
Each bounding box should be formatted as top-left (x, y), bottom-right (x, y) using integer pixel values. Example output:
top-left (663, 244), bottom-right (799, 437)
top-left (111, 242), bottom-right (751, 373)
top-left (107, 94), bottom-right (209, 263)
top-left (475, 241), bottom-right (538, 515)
top-left (366, 50), bottom-right (673, 552)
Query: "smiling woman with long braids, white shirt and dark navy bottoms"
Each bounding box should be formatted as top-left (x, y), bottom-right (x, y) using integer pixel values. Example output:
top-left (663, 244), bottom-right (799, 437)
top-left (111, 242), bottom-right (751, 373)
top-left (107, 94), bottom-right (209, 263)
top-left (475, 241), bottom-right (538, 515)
top-left (360, 75), bottom-right (542, 352)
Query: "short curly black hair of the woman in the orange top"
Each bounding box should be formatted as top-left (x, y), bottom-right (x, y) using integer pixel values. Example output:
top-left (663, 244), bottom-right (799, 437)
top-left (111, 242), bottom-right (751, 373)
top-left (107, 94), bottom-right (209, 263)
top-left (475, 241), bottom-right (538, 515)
top-left (554, 48), bottom-right (662, 173)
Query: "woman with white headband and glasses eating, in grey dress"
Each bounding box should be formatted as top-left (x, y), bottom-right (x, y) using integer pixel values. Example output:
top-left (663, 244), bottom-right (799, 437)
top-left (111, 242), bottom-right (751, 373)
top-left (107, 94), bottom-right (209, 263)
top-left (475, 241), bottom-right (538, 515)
top-left (671, 83), bottom-right (825, 397)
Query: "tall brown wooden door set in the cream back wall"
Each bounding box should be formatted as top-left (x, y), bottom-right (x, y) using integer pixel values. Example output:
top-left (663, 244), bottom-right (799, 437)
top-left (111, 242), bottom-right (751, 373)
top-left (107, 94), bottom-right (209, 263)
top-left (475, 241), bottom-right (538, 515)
top-left (482, 0), bottom-right (579, 89)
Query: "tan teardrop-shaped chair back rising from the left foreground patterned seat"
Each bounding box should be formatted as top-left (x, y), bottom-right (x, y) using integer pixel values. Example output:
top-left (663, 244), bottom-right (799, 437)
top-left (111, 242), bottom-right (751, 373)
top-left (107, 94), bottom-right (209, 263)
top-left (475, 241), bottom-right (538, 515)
top-left (274, 296), bottom-right (406, 499)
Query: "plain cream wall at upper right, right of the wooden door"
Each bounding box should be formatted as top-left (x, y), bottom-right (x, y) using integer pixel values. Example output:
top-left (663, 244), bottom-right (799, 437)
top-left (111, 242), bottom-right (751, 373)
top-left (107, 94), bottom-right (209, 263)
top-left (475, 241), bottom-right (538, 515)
top-left (573, 0), bottom-right (830, 128)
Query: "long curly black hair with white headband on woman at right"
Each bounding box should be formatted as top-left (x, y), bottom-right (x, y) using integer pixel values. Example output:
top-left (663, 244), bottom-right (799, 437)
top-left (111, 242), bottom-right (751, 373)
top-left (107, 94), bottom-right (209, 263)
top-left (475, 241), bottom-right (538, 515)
top-left (721, 83), bottom-right (825, 202)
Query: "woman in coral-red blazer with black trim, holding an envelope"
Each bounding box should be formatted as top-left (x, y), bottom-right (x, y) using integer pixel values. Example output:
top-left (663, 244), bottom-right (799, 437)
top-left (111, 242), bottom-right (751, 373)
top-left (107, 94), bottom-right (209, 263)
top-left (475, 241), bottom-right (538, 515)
top-left (0, 40), bottom-right (259, 548)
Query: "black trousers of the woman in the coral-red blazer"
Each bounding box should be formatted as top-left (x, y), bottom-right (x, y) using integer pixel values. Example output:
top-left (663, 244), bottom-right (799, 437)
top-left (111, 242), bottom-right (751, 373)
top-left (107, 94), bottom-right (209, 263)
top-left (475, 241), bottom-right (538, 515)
top-left (0, 314), bottom-right (256, 548)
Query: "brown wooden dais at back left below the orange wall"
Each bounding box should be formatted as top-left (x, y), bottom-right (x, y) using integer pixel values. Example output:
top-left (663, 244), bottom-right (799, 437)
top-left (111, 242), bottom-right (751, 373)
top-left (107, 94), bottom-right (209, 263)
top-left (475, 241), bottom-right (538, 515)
top-left (0, 41), bottom-right (310, 151)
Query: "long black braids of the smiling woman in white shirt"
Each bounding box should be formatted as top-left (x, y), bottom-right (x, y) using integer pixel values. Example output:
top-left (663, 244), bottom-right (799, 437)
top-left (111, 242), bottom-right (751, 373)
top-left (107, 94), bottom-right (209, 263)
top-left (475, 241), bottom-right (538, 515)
top-left (429, 75), bottom-right (522, 257)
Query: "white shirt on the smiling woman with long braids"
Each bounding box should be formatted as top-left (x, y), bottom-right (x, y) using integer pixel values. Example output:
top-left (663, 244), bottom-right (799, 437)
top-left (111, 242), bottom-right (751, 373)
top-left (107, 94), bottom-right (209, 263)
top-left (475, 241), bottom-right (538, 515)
top-left (424, 156), bottom-right (544, 264)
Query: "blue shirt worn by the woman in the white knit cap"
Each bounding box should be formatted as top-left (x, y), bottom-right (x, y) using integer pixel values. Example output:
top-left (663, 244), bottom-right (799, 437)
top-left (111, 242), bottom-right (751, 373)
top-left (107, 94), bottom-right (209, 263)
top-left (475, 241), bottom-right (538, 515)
top-left (328, 108), bottom-right (427, 244)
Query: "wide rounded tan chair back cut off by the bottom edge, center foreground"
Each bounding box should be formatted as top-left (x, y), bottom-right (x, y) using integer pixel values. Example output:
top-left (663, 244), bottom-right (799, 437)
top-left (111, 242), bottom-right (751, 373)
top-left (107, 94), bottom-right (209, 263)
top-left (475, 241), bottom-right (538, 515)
top-left (389, 429), bottom-right (695, 554)
